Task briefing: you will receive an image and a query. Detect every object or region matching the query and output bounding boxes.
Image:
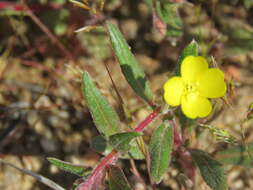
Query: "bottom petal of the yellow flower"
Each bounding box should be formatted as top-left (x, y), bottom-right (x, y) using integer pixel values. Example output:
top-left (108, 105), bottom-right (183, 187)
top-left (181, 93), bottom-right (212, 119)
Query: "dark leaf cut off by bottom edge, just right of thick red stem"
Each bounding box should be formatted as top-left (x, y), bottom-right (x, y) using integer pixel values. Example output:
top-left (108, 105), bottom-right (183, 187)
top-left (108, 165), bottom-right (132, 190)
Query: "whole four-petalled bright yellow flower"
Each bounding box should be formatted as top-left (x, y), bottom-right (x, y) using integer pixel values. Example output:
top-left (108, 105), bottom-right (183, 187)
top-left (163, 56), bottom-right (227, 119)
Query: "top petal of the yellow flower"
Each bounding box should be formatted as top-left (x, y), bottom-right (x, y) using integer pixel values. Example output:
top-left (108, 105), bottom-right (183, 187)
top-left (181, 56), bottom-right (208, 82)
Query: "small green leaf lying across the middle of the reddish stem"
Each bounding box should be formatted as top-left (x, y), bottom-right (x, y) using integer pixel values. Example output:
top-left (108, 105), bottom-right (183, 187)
top-left (109, 132), bottom-right (141, 152)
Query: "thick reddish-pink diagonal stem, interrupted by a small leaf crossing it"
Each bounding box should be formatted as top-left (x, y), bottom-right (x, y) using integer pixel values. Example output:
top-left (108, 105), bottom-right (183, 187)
top-left (77, 107), bottom-right (160, 190)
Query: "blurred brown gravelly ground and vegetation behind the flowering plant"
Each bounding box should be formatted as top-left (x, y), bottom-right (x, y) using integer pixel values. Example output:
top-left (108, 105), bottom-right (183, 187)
top-left (0, 0), bottom-right (253, 190)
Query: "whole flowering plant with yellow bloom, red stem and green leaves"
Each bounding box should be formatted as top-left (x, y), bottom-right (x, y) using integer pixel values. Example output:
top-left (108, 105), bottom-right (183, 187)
top-left (54, 22), bottom-right (231, 190)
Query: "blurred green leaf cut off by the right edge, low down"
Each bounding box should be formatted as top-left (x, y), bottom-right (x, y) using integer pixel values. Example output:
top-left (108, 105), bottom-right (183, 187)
top-left (215, 143), bottom-right (253, 167)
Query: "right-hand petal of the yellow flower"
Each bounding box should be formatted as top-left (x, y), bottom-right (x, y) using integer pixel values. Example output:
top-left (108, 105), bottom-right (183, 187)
top-left (198, 68), bottom-right (227, 98)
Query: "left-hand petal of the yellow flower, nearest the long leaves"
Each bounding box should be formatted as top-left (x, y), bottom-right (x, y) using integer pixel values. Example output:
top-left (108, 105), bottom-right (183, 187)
top-left (163, 77), bottom-right (184, 106)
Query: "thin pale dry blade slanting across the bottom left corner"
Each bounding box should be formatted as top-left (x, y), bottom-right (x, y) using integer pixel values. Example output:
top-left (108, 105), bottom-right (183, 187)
top-left (0, 159), bottom-right (65, 190)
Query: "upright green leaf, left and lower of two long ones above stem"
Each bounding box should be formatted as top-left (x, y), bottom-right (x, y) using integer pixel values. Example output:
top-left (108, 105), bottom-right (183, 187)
top-left (83, 72), bottom-right (120, 139)
